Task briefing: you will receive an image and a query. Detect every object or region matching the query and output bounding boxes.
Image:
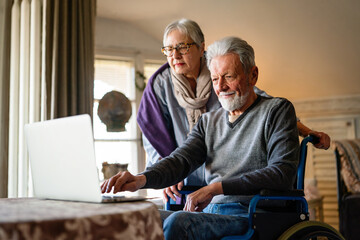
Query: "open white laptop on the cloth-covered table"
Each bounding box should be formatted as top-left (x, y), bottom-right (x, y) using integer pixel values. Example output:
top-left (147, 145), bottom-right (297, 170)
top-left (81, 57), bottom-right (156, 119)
top-left (25, 114), bottom-right (146, 203)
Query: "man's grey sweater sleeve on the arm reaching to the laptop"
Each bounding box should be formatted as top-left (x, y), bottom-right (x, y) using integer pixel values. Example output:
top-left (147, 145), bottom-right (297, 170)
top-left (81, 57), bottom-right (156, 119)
top-left (141, 117), bottom-right (206, 189)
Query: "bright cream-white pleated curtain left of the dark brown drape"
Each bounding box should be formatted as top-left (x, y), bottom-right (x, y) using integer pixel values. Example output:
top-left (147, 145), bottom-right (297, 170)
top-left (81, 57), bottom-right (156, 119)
top-left (8, 0), bottom-right (42, 197)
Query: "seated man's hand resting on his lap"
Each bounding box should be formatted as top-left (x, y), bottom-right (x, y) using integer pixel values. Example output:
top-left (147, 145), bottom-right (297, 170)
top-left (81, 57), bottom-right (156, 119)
top-left (184, 182), bottom-right (223, 212)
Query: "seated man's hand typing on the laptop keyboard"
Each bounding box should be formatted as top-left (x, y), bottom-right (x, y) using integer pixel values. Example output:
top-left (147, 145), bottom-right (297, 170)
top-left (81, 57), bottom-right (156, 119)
top-left (101, 171), bottom-right (146, 193)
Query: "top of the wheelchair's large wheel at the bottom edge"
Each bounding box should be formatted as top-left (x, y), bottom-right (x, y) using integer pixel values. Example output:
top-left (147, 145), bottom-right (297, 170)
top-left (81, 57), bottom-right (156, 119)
top-left (278, 221), bottom-right (345, 240)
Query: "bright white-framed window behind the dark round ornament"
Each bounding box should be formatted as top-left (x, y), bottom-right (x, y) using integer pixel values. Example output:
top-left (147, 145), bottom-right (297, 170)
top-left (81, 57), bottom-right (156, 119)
top-left (93, 59), bottom-right (139, 179)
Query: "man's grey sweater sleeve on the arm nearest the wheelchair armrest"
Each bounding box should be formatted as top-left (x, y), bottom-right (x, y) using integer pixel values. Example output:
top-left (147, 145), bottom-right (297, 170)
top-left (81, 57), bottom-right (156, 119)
top-left (222, 99), bottom-right (299, 195)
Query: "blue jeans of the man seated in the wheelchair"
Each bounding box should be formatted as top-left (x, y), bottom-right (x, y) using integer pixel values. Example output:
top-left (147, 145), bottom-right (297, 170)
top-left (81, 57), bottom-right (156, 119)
top-left (160, 203), bottom-right (248, 240)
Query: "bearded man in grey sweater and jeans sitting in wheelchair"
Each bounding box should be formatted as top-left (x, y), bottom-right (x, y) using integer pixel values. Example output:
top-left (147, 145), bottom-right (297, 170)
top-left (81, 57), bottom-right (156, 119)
top-left (102, 37), bottom-right (299, 239)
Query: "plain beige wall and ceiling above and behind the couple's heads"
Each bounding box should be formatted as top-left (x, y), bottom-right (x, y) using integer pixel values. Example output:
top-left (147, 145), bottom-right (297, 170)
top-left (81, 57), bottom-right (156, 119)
top-left (97, 0), bottom-right (360, 99)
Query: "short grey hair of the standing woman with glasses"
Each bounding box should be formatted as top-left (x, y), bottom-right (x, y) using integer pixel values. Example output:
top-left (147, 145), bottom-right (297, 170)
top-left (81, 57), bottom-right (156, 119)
top-left (163, 18), bottom-right (205, 46)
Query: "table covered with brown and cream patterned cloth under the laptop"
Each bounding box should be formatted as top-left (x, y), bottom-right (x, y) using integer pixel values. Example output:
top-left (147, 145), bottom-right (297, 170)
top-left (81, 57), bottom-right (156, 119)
top-left (0, 198), bottom-right (164, 240)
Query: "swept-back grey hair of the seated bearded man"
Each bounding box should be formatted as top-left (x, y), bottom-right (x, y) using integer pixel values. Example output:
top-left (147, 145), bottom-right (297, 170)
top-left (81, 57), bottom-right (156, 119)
top-left (206, 37), bottom-right (255, 73)
